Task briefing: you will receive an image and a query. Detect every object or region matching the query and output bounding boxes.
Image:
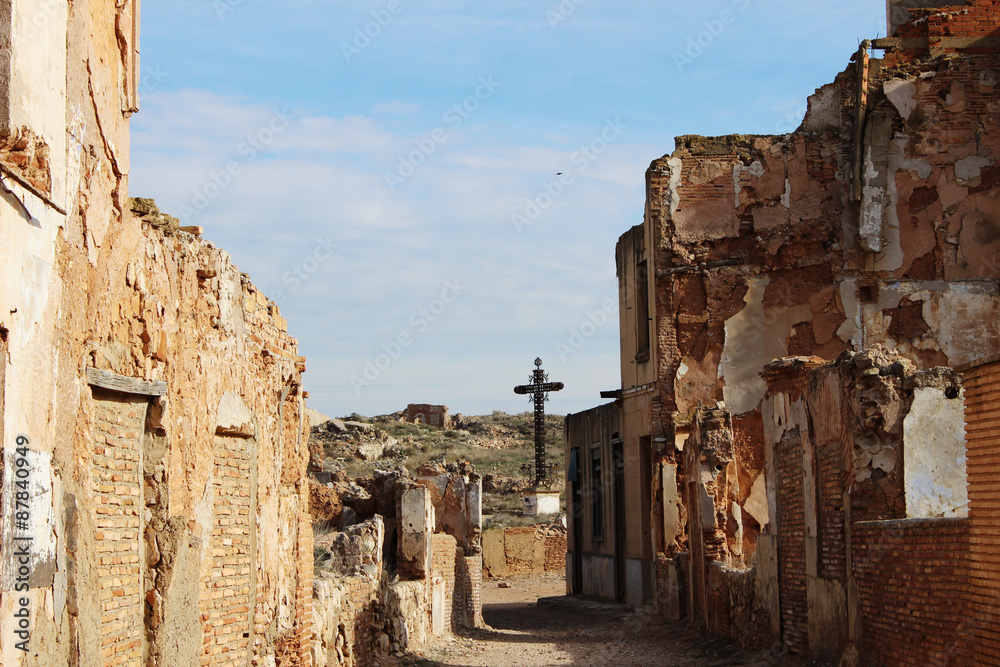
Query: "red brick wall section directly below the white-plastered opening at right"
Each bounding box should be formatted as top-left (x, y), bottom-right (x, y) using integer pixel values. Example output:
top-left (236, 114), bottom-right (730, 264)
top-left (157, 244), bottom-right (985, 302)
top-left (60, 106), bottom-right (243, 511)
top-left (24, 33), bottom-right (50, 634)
top-left (853, 519), bottom-right (974, 667)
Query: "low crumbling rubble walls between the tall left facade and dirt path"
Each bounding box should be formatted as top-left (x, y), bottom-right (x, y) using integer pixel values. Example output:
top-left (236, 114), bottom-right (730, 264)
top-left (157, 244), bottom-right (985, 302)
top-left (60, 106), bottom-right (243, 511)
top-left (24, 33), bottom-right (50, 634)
top-left (310, 464), bottom-right (483, 667)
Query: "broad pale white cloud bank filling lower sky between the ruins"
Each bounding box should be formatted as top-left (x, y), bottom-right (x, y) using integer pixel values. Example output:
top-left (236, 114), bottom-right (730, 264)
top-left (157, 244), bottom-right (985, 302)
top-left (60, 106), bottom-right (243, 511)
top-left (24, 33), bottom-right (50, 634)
top-left (131, 90), bottom-right (650, 414)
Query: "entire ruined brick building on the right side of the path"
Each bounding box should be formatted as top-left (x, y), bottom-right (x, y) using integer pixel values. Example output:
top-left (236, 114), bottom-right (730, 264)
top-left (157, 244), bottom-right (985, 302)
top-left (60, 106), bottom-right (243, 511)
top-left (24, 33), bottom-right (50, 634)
top-left (567, 0), bottom-right (1000, 665)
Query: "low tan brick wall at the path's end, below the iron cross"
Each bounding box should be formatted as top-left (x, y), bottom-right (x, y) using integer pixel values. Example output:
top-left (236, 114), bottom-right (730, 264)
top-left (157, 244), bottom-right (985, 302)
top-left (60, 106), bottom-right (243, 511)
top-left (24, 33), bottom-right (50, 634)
top-left (483, 525), bottom-right (566, 578)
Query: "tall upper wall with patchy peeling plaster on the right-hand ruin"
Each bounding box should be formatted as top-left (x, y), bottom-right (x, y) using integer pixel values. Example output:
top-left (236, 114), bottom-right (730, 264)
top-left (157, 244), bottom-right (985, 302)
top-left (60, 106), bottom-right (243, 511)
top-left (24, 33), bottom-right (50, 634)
top-left (636, 39), bottom-right (1000, 435)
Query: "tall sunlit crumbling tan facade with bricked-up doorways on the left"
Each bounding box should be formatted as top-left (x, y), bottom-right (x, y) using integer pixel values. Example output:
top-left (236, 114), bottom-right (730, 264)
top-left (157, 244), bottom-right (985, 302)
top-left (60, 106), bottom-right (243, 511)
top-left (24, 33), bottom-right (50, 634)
top-left (0, 0), bottom-right (312, 666)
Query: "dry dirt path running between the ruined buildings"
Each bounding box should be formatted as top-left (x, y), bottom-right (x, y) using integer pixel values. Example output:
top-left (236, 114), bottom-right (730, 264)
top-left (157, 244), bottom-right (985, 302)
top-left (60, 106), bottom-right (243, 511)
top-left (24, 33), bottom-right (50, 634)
top-left (383, 574), bottom-right (804, 667)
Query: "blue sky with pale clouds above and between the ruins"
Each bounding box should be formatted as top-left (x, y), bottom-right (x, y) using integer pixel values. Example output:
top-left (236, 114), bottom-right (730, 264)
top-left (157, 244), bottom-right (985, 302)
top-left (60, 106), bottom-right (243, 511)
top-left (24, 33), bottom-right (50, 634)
top-left (130, 0), bottom-right (885, 415)
